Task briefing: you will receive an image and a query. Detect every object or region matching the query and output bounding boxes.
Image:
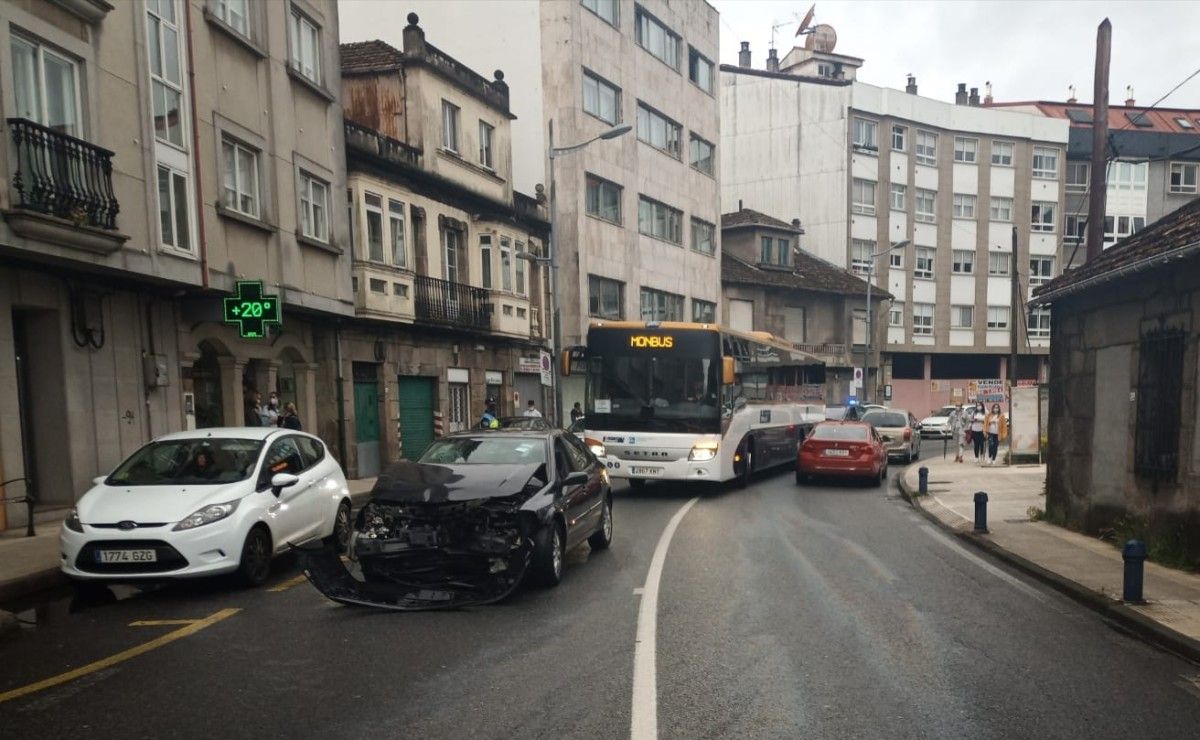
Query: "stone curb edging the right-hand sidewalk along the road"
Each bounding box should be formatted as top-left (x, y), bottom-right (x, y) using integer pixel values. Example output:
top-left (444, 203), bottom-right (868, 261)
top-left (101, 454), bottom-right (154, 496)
top-left (896, 474), bottom-right (1200, 663)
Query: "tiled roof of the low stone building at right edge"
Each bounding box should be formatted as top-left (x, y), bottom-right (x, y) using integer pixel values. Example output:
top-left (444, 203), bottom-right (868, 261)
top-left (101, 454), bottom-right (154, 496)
top-left (1032, 199), bottom-right (1200, 303)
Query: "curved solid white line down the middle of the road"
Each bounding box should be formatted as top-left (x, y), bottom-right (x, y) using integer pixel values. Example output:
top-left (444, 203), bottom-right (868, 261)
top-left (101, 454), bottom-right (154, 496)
top-left (629, 497), bottom-right (700, 740)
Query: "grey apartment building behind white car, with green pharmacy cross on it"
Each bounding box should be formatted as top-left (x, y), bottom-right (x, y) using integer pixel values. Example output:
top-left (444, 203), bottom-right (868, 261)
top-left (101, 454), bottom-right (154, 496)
top-left (0, 0), bottom-right (353, 528)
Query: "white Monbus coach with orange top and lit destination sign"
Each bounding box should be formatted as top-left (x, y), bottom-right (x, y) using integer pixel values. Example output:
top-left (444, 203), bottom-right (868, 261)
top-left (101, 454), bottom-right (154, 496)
top-left (562, 321), bottom-right (824, 488)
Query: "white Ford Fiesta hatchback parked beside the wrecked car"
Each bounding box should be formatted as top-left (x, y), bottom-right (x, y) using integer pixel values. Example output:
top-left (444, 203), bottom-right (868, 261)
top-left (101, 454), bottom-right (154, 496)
top-left (60, 427), bottom-right (350, 585)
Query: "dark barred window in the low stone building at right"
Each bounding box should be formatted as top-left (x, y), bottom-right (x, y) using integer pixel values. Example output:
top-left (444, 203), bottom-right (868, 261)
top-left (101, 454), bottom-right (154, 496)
top-left (1134, 330), bottom-right (1187, 480)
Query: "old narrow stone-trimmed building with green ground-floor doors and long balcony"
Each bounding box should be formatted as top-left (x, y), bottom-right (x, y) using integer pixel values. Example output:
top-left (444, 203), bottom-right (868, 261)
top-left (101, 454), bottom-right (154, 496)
top-left (326, 23), bottom-right (551, 477)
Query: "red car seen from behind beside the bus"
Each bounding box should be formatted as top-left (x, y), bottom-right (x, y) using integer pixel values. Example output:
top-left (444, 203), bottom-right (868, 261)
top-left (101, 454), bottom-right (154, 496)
top-left (796, 421), bottom-right (888, 486)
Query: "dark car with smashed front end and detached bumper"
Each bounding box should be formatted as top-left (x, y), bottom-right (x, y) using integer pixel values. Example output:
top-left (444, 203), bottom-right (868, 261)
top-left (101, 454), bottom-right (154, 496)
top-left (298, 429), bottom-right (612, 610)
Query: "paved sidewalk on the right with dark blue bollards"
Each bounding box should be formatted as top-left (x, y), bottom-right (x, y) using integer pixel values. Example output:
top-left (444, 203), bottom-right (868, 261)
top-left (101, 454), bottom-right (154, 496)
top-left (899, 457), bottom-right (1200, 661)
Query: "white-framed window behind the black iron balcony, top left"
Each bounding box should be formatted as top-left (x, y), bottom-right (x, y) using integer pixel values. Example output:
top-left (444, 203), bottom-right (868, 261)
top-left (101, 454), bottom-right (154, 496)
top-left (11, 35), bottom-right (79, 137)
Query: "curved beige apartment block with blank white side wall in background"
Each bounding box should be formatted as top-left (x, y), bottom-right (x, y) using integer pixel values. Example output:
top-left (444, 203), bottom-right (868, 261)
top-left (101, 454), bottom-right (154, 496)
top-left (721, 41), bottom-right (1068, 415)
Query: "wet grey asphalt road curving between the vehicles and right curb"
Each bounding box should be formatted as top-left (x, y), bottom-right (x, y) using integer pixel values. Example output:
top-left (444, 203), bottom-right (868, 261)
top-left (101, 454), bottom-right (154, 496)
top-left (0, 471), bottom-right (1200, 740)
